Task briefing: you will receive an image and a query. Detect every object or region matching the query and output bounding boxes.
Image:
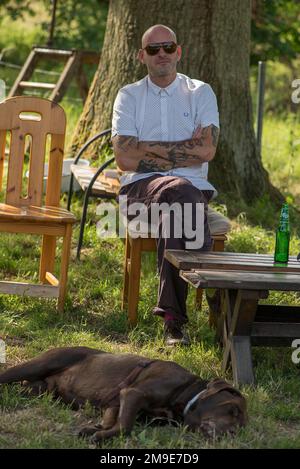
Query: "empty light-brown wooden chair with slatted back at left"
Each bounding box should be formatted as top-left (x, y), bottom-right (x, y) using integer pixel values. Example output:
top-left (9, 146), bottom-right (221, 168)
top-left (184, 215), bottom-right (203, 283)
top-left (0, 96), bottom-right (76, 311)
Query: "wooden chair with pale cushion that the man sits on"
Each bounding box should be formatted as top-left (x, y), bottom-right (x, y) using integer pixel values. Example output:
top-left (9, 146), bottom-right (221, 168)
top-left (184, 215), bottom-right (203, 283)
top-left (122, 207), bottom-right (230, 326)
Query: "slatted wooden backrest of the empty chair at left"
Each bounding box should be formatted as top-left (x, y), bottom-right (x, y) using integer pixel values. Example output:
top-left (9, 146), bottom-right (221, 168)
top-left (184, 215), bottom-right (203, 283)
top-left (0, 96), bottom-right (66, 207)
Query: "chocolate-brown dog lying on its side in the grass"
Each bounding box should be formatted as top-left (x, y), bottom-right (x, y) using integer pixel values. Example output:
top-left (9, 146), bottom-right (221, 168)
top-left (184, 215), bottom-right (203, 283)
top-left (0, 347), bottom-right (247, 442)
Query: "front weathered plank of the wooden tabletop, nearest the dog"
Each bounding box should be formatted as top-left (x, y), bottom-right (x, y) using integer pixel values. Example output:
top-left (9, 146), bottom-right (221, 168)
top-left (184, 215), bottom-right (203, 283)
top-left (180, 269), bottom-right (300, 291)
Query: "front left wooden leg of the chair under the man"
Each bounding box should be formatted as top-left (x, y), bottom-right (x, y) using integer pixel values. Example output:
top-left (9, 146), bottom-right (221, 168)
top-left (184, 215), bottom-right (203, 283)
top-left (128, 238), bottom-right (142, 326)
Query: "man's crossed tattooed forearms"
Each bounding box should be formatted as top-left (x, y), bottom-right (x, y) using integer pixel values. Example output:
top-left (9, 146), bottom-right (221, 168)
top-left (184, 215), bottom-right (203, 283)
top-left (112, 125), bottom-right (219, 173)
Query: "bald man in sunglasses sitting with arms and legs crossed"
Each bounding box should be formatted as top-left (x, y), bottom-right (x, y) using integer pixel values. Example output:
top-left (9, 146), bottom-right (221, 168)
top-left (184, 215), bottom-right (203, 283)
top-left (112, 25), bottom-right (219, 345)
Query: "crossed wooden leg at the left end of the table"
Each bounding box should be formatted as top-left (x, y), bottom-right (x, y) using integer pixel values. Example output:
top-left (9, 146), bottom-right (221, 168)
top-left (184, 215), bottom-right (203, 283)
top-left (222, 290), bottom-right (262, 386)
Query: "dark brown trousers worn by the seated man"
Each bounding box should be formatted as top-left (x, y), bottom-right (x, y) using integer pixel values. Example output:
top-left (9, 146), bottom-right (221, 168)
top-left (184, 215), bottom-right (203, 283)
top-left (119, 175), bottom-right (213, 323)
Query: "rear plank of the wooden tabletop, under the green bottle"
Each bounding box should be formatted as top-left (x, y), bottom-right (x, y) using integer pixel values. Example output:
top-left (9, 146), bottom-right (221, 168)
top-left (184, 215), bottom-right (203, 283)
top-left (165, 249), bottom-right (300, 273)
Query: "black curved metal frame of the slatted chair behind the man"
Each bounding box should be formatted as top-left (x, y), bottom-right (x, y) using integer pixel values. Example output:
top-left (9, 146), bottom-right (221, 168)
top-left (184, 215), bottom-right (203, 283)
top-left (67, 129), bottom-right (116, 259)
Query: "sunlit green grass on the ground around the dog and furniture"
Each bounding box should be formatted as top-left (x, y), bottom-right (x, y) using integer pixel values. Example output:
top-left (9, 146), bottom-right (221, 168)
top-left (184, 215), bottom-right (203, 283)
top-left (0, 185), bottom-right (300, 449)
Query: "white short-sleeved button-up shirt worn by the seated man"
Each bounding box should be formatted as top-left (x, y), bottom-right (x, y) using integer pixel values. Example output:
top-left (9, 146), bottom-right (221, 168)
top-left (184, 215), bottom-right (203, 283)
top-left (112, 73), bottom-right (219, 195)
